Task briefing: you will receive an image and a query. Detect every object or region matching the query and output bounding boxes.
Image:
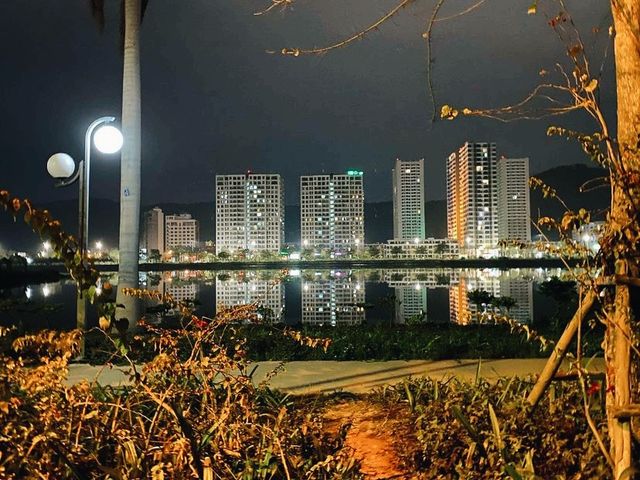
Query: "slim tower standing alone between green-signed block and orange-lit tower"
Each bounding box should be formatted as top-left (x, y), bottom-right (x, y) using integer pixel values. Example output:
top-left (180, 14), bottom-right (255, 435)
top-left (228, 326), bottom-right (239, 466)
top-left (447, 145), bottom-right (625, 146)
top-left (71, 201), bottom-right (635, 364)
top-left (392, 158), bottom-right (425, 240)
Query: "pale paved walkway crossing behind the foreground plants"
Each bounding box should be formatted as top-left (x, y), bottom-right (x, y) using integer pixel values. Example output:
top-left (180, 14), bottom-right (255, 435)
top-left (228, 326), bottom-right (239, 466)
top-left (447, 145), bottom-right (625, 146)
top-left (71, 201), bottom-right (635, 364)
top-left (68, 358), bottom-right (604, 394)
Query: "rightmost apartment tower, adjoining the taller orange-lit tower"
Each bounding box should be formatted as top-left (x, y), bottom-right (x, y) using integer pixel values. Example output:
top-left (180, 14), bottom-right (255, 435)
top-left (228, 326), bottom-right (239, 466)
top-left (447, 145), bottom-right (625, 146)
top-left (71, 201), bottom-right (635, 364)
top-left (497, 157), bottom-right (531, 242)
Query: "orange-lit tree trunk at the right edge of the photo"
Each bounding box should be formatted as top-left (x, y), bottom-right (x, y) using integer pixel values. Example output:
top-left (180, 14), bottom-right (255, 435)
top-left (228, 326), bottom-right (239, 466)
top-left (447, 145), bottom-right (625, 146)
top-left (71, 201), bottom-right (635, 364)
top-left (605, 0), bottom-right (640, 479)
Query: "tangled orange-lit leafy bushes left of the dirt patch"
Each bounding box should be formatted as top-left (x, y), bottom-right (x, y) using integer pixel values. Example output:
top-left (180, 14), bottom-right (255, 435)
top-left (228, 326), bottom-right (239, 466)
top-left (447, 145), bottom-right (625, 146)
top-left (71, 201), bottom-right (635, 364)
top-left (0, 291), bottom-right (350, 480)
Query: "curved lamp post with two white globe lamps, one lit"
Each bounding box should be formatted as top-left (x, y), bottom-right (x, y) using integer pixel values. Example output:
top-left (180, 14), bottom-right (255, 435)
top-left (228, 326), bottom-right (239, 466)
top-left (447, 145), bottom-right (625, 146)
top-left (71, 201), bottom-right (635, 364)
top-left (47, 117), bottom-right (123, 357)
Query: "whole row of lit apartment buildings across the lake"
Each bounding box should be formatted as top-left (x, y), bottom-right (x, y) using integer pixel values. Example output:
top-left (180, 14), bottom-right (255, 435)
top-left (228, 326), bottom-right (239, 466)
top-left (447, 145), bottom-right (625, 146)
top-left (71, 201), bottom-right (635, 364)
top-left (150, 142), bottom-right (531, 256)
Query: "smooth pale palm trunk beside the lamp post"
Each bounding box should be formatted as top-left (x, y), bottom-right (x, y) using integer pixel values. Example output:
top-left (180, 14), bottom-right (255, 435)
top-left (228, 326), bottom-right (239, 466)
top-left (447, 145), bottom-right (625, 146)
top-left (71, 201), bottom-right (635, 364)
top-left (117, 0), bottom-right (141, 325)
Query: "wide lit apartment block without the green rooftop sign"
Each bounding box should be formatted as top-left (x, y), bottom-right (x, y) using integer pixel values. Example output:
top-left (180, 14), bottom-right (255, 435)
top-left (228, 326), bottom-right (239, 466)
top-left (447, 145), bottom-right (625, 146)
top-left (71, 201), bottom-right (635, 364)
top-left (216, 173), bottom-right (284, 253)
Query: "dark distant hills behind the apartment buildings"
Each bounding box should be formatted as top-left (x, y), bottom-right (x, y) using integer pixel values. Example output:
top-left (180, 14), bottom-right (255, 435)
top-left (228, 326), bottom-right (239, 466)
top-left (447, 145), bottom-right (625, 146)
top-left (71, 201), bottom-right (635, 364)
top-left (0, 164), bottom-right (609, 251)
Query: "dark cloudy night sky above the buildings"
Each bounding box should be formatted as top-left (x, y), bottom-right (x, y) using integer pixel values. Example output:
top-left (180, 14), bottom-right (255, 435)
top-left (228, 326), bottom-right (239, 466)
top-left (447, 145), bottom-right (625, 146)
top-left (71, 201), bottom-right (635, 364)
top-left (0, 0), bottom-right (614, 204)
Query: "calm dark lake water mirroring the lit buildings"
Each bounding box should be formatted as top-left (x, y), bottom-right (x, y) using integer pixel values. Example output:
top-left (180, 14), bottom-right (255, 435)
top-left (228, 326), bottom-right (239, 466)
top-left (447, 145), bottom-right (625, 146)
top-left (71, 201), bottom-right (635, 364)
top-left (0, 269), bottom-right (563, 329)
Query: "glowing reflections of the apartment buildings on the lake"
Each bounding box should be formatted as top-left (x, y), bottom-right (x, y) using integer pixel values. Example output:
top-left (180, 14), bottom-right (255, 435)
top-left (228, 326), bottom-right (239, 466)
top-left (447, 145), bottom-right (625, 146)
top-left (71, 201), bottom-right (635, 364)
top-left (135, 269), bottom-right (540, 325)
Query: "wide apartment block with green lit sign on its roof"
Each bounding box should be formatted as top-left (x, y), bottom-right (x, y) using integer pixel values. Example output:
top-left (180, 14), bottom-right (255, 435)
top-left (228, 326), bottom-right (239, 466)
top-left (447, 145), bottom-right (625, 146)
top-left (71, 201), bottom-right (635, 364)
top-left (300, 170), bottom-right (364, 254)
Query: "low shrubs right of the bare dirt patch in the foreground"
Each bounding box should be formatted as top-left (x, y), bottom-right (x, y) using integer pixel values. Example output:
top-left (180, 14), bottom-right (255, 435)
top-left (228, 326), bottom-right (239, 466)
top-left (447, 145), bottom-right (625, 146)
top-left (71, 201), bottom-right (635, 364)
top-left (377, 378), bottom-right (611, 479)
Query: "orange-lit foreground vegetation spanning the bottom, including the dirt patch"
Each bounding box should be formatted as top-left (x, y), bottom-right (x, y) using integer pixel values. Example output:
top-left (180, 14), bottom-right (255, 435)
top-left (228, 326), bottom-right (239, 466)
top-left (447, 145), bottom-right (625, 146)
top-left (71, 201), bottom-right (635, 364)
top-left (0, 317), bottom-right (609, 480)
